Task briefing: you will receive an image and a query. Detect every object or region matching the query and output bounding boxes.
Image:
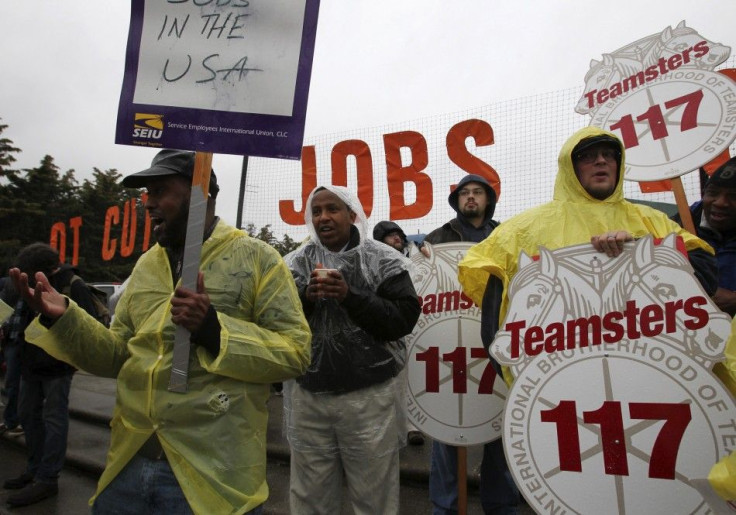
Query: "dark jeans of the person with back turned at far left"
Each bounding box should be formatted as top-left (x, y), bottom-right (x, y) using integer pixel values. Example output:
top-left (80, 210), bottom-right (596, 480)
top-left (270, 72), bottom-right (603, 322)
top-left (18, 374), bottom-right (72, 483)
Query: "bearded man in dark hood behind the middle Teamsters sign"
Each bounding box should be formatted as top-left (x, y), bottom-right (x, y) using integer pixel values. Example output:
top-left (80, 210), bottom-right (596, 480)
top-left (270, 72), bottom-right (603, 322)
top-left (424, 174), bottom-right (519, 515)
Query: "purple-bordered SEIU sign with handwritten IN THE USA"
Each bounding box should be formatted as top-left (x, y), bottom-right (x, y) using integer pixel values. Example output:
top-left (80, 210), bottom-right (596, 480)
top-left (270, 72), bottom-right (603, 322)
top-left (115, 0), bottom-right (319, 159)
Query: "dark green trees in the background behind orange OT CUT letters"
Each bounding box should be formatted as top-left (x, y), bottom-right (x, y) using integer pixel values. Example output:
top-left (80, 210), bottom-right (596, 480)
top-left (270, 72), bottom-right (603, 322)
top-left (0, 118), bottom-right (299, 282)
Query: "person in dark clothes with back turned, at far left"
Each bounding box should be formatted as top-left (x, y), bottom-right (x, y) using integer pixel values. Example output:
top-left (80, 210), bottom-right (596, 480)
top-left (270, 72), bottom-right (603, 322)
top-left (3, 243), bottom-right (95, 506)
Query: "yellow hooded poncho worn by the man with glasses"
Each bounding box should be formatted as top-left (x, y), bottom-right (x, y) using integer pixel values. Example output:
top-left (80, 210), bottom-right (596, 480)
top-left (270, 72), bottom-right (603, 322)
top-left (458, 127), bottom-right (713, 320)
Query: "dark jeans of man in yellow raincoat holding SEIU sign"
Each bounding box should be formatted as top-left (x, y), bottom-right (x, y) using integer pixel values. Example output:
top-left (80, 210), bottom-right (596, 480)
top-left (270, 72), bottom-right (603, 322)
top-left (92, 455), bottom-right (263, 515)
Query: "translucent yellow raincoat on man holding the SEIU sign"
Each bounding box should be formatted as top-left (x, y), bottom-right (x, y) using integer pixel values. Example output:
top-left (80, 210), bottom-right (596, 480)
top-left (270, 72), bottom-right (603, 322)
top-left (26, 222), bottom-right (311, 514)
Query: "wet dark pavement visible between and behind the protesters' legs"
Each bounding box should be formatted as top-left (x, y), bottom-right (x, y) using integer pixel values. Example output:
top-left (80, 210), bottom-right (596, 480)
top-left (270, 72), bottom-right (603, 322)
top-left (0, 372), bottom-right (533, 515)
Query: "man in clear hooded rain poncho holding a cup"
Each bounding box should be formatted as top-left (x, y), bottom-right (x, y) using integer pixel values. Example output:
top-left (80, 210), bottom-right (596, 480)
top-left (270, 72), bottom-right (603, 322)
top-left (284, 186), bottom-right (421, 515)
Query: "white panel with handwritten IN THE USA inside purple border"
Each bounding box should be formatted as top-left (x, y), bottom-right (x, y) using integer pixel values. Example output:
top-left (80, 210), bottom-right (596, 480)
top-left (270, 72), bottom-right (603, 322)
top-left (134, 0), bottom-right (305, 116)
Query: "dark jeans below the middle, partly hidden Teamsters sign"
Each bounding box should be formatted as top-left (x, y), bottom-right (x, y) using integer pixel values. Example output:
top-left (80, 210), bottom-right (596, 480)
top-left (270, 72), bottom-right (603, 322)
top-left (429, 438), bottom-right (519, 515)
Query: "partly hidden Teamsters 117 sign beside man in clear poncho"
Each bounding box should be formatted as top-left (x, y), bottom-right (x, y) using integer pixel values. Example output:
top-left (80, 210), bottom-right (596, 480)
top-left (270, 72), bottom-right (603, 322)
top-left (407, 242), bottom-right (507, 446)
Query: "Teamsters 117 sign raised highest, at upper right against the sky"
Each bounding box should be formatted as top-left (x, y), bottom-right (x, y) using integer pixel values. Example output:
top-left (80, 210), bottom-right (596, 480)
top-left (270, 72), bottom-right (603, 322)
top-left (575, 21), bottom-right (736, 181)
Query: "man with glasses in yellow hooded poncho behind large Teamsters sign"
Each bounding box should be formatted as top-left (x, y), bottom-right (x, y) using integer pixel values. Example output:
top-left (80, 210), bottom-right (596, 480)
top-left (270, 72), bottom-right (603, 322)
top-left (459, 127), bottom-right (717, 388)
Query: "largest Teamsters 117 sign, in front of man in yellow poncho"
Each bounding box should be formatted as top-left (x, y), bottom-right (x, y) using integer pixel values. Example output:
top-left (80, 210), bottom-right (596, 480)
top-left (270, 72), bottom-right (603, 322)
top-left (491, 235), bottom-right (736, 514)
